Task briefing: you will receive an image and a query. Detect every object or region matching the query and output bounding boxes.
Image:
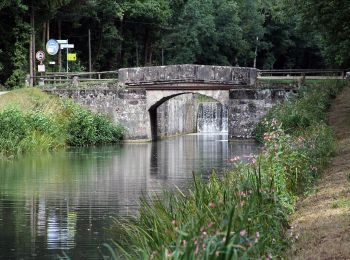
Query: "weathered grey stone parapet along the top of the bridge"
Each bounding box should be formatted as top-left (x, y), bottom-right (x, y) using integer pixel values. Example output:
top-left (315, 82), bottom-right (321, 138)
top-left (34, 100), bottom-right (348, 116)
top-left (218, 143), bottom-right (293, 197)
top-left (118, 64), bottom-right (257, 86)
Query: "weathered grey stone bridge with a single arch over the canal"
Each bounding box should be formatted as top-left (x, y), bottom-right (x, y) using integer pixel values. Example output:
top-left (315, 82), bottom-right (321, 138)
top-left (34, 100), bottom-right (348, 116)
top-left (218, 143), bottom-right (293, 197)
top-left (48, 65), bottom-right (291, 140)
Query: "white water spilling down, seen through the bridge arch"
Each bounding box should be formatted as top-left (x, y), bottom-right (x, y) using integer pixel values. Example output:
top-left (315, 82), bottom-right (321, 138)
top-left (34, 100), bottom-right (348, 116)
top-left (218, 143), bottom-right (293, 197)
top-left (197, 102), bottom-right (228, 133)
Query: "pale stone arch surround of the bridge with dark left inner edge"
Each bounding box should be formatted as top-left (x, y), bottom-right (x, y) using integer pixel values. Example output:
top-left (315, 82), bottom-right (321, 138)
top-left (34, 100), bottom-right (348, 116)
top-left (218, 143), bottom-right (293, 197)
top-left (146, 90), bottom-right (229, 141)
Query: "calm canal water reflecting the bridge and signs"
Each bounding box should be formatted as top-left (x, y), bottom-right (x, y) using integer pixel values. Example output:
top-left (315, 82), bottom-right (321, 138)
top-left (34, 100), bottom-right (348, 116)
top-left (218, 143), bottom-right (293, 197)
top-left (0, 134), bottom-right (257, 259)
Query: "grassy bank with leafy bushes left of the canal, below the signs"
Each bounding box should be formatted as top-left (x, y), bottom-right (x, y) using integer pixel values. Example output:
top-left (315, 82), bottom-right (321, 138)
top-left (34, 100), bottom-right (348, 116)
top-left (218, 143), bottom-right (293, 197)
top-left (0, 88), bottom-right (123, 157)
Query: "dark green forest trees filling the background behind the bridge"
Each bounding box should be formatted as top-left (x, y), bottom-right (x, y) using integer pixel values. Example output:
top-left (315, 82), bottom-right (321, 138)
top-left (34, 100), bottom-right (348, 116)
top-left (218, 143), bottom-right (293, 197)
top-left (0, 0), bottom-right (350, 87)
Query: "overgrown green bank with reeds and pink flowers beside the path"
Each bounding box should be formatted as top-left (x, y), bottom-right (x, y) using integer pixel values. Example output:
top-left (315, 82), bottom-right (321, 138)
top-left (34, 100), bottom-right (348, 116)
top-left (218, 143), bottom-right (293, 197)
top-left (108, 81), bottom-right (345, 259)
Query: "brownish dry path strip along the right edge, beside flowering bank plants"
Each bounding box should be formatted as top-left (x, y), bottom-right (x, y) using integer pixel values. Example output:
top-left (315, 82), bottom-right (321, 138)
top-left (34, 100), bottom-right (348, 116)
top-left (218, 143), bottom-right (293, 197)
top-left (288, 88), bottom-right (350, 259)
